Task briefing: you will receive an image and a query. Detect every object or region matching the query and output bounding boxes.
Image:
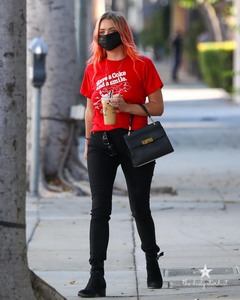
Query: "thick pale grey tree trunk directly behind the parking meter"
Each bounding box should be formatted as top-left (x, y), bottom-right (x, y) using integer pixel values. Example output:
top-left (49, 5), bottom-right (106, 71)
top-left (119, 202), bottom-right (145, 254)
top-left (27, 0), bottom-right (86, 193)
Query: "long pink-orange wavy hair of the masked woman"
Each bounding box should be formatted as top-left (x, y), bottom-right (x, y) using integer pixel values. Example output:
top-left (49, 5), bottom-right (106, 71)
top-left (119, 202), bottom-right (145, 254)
top-left (88, 11), bottom-right (140, 70)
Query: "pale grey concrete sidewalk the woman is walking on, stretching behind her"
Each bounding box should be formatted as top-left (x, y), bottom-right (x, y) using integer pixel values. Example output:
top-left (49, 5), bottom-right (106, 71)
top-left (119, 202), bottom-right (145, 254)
top-left (27, 65), bottom-right (240, 300)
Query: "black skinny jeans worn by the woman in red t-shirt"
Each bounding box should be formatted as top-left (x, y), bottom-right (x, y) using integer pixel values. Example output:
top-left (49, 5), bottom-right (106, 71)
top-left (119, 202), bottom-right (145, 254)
top-left (87, 129), bottom-right (160, 263)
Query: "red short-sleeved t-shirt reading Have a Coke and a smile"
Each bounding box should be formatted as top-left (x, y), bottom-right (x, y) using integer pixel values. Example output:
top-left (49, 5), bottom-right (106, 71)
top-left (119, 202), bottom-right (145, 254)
top-left (80, 56), bottom-right (163, 132)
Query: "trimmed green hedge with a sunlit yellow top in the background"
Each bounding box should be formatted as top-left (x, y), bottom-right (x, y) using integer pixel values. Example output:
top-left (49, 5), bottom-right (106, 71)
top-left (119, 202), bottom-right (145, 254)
top-left (198, 42), bottom-right (235, 93)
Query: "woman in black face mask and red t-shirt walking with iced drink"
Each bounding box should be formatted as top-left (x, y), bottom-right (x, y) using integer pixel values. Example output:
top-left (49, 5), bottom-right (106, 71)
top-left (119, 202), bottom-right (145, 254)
top-left (78, 11), bottom-right (163, 298)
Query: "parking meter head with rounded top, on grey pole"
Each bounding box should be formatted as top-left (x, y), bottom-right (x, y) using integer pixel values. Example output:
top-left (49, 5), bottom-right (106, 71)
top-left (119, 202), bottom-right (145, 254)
top-left (28, 38), bottom-right (48, 88)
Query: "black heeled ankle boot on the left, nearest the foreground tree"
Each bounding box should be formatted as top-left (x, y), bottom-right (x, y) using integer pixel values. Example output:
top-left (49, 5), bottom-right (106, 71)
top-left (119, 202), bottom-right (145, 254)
top-left (78, 262), bottom-right (106, 298)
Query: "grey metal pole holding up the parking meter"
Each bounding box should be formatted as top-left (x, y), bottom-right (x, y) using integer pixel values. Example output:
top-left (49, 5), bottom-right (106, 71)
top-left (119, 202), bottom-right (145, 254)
top-left (30, 88), bottom-right (41, 197)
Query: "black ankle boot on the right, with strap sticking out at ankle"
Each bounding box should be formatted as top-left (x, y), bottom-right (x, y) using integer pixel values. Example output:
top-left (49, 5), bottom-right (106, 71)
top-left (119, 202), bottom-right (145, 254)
top-left (146, 252), bottom-right (164, 289)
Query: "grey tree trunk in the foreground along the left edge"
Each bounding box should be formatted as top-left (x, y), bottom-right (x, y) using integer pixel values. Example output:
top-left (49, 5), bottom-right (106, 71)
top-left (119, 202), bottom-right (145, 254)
top-left (0, 0), bottom-right (65, 300)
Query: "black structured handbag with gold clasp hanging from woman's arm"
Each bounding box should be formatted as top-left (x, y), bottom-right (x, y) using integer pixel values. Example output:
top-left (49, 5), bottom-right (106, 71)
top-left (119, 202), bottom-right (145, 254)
top-left (123, 104), bottom-right (174, 167)
